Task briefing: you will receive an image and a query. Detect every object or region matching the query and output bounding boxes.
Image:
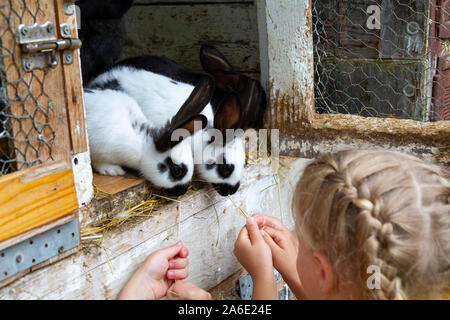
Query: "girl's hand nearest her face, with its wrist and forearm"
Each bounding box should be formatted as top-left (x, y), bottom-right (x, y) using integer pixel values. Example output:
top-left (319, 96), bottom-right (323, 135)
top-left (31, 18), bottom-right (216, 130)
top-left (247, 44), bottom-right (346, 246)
top-left (252, 215), bottom-right (302, 299)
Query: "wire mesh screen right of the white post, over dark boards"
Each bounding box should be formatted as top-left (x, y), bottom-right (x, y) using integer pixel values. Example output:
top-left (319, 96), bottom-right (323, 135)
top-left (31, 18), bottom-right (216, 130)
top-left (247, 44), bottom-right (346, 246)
top-left (312, 0), bottom-right (450, 121)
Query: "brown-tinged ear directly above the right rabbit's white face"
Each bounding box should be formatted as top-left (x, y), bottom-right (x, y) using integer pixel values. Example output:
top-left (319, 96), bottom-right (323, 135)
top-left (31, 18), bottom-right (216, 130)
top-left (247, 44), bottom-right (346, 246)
top-left (214, 92), bottom-right (242, 133)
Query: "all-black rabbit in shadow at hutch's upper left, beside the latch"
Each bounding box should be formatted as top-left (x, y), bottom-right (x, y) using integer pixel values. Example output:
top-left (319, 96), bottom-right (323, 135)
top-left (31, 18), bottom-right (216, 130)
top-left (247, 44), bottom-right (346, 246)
top-left (75, 0), bottom-right (133, 83)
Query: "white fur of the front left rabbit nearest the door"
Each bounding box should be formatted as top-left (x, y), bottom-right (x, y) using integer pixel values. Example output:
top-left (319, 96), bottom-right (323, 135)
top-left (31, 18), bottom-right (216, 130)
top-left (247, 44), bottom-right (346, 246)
top-left (84, 90), bottom-right (193, 189)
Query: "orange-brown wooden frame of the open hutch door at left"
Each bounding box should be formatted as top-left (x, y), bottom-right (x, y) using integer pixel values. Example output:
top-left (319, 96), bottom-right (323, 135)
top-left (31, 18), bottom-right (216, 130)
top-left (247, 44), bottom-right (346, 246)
top-left (0, 0), bottom-right (93, 245)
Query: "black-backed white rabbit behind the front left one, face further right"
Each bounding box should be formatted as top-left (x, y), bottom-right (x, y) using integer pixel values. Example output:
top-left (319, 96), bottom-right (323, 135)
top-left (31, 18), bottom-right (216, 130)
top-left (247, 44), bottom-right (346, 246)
top-left (90, 47), bottom-right (265, 196)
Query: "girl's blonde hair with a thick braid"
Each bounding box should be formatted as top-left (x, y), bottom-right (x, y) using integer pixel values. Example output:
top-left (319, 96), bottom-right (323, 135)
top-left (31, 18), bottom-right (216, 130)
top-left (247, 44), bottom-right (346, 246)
top-left (293, 150), bottom-right (450, 299)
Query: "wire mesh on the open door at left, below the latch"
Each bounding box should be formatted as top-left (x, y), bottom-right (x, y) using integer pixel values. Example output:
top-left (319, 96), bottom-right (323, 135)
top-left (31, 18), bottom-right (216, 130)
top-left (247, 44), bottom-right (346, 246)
top-left (0, 0), bottom-right (55, 175)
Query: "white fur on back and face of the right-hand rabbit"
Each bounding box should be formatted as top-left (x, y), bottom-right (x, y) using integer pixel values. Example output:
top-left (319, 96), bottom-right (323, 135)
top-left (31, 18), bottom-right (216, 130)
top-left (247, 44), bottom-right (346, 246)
top-left (91, 66), bottom-right (245, 189)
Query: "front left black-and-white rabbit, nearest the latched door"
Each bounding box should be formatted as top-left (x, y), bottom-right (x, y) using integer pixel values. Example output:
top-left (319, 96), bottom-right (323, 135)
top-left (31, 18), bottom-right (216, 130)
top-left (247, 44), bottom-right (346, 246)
top-left (85, 79), bottom-right (213, 196)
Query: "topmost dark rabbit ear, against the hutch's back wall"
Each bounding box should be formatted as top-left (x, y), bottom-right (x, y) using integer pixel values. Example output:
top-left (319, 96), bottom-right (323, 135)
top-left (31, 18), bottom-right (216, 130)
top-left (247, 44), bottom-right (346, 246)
top-left (200, 45), bottom-right (240, 90)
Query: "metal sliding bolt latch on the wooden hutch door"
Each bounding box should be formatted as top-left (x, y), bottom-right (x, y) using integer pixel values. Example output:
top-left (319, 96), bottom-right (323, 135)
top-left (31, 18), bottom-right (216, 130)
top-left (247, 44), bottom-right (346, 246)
top-left (17, 22), bottom-right (81, 71)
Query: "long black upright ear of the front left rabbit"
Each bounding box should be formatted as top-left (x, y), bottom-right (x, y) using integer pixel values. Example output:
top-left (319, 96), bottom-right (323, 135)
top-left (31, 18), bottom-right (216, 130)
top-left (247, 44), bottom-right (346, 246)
top-left (170, 75), bottom-right (214, 129)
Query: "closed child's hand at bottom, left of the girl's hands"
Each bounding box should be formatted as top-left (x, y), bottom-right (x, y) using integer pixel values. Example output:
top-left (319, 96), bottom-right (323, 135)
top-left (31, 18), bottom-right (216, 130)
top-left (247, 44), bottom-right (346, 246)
top-left (119, 241), bottom-right (189, 300)
